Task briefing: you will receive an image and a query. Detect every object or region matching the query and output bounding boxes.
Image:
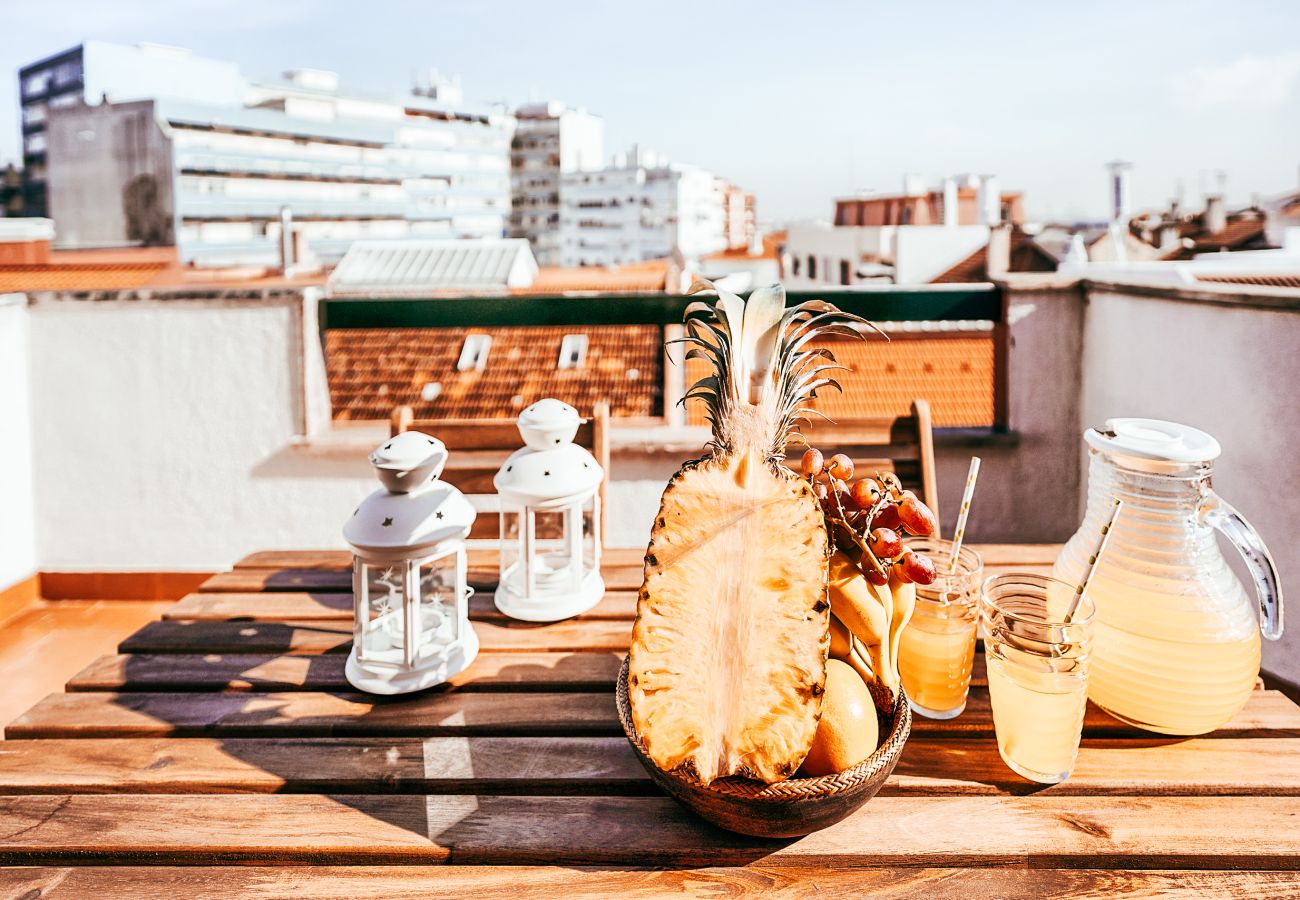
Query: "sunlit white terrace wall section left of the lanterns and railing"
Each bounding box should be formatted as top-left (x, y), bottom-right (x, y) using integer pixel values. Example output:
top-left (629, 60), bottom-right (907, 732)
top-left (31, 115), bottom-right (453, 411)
top-left (29, 293), bottom-right (356, 571)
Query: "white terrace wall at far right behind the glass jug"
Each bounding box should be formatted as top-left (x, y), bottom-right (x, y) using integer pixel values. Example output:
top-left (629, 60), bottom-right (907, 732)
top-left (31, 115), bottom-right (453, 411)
top-left (1082, 284), bottom-right (1300, 683)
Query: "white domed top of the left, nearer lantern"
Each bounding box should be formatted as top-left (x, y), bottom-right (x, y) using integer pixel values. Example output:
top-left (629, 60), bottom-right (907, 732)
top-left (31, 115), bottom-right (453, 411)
top-left (343, 432), bottom-right (477, 558)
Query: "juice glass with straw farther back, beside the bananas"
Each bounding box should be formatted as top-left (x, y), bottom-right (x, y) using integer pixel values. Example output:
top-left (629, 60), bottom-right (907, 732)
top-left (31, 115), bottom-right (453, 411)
top-left (898, 537), bottom-right (984, 719)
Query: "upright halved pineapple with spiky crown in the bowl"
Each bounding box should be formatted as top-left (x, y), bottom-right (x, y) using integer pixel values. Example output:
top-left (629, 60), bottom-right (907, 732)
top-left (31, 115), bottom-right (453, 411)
top-left (628, 282), bottom-right (861, 784)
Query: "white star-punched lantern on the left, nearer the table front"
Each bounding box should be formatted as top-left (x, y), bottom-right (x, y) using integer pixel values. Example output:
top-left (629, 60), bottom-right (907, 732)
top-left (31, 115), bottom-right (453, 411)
top-left (343, 432), bottom-right (478, 693)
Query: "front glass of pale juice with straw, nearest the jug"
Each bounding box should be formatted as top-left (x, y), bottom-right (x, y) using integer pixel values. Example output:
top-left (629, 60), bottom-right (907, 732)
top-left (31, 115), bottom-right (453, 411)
top-left (980, 574), bottom-right (1096, 784)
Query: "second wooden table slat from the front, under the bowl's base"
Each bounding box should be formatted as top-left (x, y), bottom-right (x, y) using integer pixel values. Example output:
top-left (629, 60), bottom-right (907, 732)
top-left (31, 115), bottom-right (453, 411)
top-left (0, 793), bottom-right (1300, 869)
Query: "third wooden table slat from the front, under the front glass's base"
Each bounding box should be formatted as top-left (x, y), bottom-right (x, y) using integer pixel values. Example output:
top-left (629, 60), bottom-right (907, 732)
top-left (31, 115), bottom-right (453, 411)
top-left (0, 736), bottom-right (1300, 797)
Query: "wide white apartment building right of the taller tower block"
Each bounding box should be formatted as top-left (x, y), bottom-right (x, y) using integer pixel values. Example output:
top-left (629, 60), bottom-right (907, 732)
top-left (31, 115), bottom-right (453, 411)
top-left (560, 148), bottom-right (729, 267)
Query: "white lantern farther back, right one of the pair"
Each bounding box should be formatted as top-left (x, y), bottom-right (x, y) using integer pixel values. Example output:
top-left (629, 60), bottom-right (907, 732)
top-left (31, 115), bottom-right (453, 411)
top-left (493, 399), bottom-right (605, 622)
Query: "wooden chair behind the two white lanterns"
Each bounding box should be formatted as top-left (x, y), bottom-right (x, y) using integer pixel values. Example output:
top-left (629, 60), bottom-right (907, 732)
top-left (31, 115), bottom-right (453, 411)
top-left (389, 403), bottom-right (610, 542)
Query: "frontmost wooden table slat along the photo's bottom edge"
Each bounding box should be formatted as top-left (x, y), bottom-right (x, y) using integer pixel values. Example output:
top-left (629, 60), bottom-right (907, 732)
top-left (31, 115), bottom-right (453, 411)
top-left (10, 864), bottom-right (1300, 900)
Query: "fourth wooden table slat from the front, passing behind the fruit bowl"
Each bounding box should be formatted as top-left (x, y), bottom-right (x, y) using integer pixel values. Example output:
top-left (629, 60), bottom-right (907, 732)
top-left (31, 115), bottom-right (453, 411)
top-left (5, 688), bottom-right (1300, 740)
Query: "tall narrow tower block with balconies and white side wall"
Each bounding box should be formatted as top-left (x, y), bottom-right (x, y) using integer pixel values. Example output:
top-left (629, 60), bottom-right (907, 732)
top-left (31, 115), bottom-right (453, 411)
top-left (510, 100), bottom-right (605, 265)
